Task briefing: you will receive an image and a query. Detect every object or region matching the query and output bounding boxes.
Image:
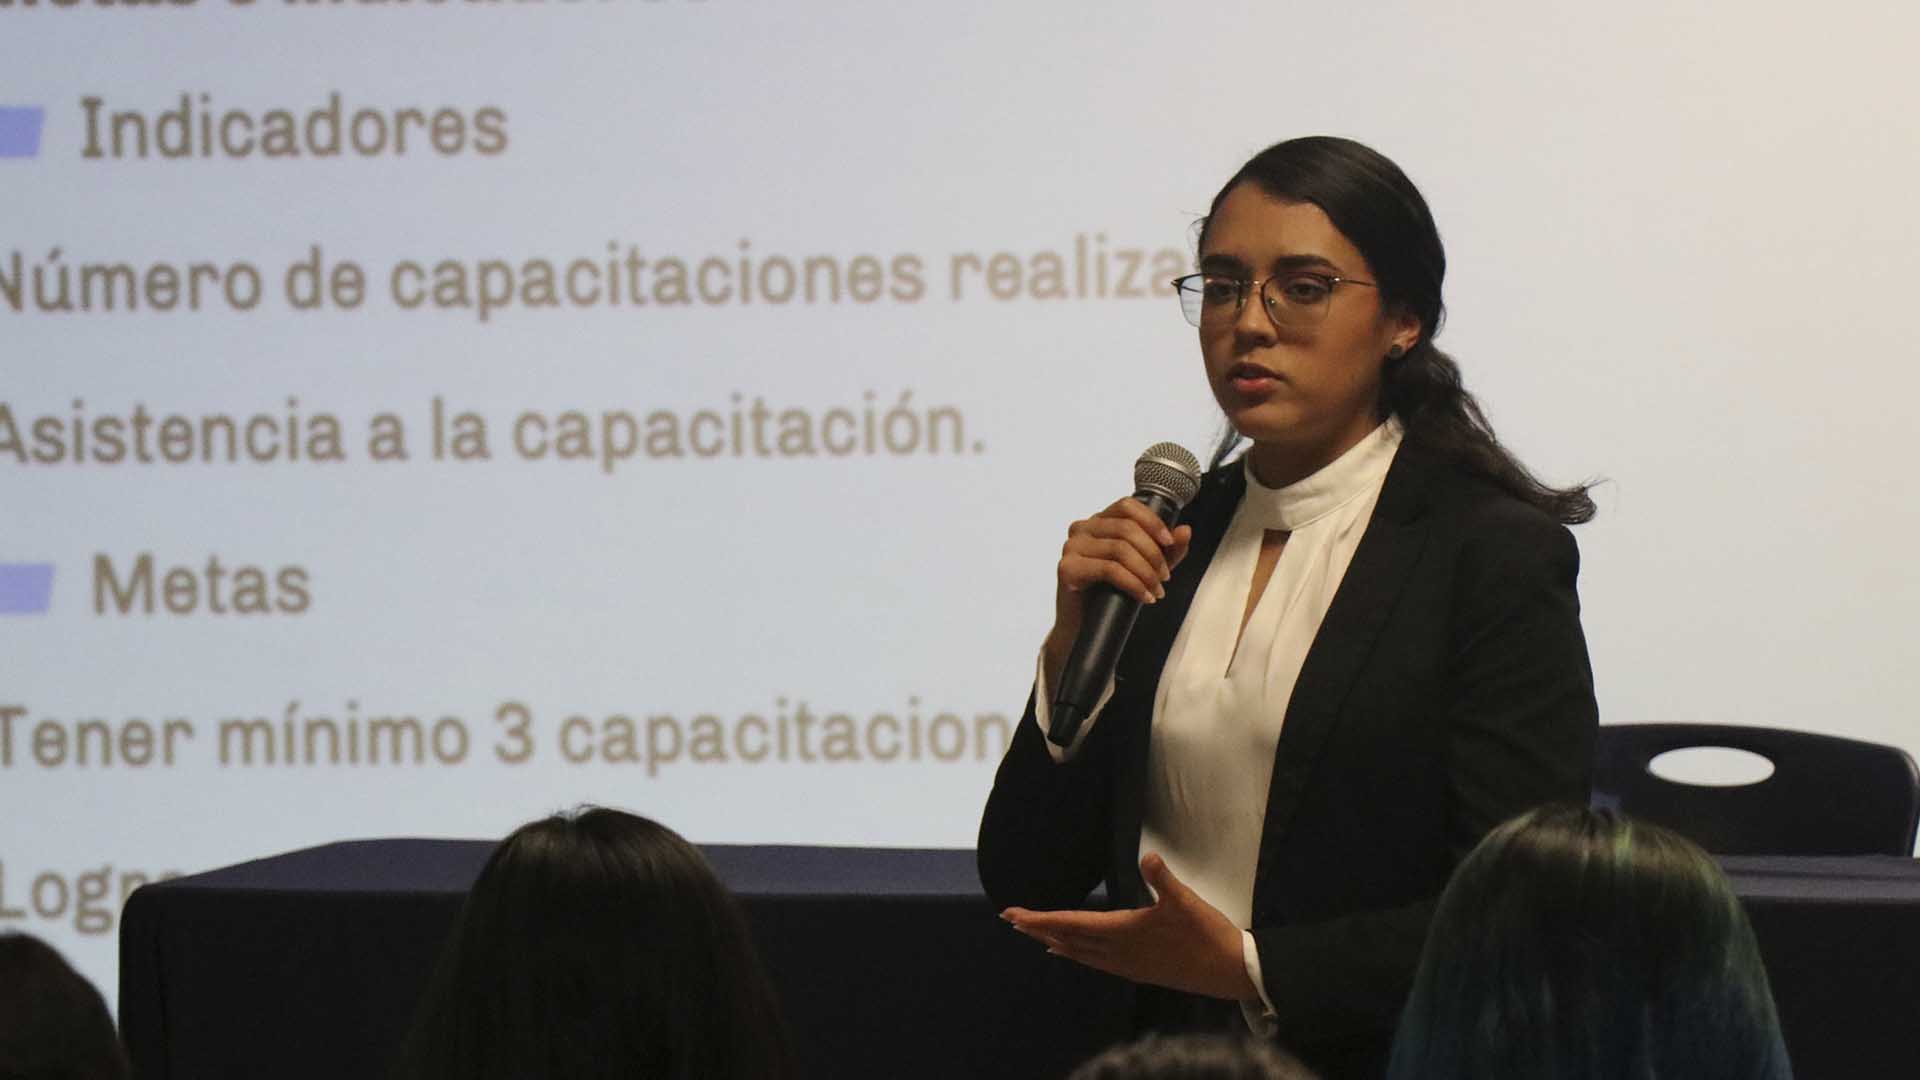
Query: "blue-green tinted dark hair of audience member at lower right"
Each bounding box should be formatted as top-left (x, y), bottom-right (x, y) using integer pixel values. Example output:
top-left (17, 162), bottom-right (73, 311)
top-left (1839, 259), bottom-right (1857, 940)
top-left (1388, 807), bottom-right (1793, 1080)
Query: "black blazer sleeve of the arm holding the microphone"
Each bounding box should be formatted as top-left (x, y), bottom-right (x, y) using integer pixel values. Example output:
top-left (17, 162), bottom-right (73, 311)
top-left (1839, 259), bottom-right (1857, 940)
top-left (975, 680), bottom-right (1119, 911)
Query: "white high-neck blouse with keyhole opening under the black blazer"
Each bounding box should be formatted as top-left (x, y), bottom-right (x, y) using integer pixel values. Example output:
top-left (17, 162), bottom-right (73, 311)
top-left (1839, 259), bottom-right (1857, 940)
top-left (1033, 419), bottom-right (1402, 1022)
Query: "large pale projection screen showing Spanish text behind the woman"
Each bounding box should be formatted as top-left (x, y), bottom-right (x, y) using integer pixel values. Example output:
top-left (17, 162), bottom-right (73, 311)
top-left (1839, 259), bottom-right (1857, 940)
top-left (0, 0), bottom-right (1920, 995)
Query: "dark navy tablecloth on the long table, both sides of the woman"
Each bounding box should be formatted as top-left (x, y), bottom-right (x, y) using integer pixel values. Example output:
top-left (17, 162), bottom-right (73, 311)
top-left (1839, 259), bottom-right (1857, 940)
top-left (121, 840), bottom-right (1920, 1080)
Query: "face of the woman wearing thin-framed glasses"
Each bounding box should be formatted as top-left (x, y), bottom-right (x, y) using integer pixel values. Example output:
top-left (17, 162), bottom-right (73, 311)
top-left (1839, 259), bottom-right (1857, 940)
top-left (1200, 183), bottom-right (1419, 475)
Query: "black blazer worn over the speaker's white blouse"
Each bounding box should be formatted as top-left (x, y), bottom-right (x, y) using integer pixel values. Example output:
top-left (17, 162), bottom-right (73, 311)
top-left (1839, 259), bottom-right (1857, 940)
top-left (979, 434), bottom-right (1597, 1080)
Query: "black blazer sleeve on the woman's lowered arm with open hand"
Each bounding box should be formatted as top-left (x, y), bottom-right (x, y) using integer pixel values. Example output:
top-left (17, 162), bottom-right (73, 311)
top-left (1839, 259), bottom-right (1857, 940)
top-left (1252, 500), bottom-right (1599, 1042)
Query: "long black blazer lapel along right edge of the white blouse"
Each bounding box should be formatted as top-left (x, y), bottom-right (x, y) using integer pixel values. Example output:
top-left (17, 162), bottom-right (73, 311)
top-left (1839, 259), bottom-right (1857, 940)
top-left (1254, 440), bottom-right (1434, 899)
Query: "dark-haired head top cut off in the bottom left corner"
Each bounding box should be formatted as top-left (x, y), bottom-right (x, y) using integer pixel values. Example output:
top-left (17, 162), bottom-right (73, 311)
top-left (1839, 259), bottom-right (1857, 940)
top-left (0, 934), bottom-right (129, 1080)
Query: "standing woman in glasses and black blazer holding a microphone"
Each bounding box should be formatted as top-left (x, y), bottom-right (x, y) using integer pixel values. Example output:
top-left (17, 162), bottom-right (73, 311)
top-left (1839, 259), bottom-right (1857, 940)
top-left (979, 138), bottom-right (1596, 1080)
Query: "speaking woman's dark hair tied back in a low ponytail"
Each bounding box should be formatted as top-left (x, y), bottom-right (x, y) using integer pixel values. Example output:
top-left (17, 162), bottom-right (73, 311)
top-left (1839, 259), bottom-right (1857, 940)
top-left (1198, 135), bottom-right (1594, 525)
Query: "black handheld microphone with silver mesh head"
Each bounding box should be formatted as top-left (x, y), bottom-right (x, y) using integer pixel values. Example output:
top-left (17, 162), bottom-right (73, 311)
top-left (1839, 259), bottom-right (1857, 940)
top-left (1046, 442), bottom-right (1200, 746)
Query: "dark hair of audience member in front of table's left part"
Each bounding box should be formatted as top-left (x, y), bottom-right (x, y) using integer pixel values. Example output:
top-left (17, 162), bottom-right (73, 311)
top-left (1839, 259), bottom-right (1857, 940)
top-left (397, 809), bottom-right (793, 1080)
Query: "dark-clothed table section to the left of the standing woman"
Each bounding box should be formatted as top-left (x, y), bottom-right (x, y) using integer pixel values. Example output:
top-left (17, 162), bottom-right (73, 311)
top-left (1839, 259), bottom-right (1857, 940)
top-left (121, 840), bottom-right (1131, 1080)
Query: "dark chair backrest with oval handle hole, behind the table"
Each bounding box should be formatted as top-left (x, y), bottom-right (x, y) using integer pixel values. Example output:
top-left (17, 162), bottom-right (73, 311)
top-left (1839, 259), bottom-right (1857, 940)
top-left (1594, 724), bottom-right (1920, 855)
